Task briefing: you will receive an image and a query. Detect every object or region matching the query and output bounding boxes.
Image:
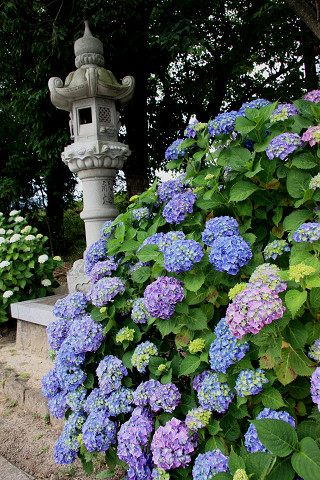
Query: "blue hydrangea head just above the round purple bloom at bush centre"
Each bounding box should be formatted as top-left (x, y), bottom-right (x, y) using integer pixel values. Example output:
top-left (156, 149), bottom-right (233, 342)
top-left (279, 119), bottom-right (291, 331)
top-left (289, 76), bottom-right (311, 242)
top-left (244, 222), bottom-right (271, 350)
top-left (164, 240), bottom-right (204, 273)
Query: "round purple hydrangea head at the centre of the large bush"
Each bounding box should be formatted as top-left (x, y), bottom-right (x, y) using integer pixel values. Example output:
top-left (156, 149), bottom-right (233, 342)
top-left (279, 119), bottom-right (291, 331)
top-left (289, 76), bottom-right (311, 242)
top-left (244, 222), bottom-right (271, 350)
top-left (144, 277), bottom-right (184, 320)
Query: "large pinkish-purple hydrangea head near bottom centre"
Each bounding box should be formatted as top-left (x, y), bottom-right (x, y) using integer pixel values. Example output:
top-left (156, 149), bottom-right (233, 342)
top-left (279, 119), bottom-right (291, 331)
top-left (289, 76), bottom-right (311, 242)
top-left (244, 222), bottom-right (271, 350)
top-left (151, 418), bottom-right (197, 470)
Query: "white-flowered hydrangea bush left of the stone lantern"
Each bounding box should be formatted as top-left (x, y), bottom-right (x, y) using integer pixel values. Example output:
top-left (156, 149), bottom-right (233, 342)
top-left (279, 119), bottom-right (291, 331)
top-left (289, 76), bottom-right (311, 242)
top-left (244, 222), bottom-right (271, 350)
top-left (0, 210), bottom-right (63, 323)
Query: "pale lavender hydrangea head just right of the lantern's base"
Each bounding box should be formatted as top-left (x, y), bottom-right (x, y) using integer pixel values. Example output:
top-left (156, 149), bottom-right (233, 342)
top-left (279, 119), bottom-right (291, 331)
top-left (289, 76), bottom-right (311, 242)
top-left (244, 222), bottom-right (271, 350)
top-left (87, 277), bottom-right (126, 308)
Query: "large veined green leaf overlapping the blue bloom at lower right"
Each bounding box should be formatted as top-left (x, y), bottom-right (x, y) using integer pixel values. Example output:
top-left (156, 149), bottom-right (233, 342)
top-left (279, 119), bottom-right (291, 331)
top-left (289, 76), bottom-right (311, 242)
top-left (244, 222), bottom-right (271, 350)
top-left (252, 418), bottom-right (298, 457)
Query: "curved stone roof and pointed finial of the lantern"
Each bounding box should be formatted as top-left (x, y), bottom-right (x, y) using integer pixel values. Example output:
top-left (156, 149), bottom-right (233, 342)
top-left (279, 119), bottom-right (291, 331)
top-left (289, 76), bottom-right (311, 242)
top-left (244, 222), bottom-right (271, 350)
top-left (49, 21), bottom-right (135, 112)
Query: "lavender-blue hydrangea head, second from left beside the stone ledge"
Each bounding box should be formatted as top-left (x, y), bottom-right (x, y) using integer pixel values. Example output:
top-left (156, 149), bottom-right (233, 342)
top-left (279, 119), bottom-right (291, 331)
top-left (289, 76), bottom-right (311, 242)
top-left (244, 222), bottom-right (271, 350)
top-left (68, 315), bottom-right (105, 354)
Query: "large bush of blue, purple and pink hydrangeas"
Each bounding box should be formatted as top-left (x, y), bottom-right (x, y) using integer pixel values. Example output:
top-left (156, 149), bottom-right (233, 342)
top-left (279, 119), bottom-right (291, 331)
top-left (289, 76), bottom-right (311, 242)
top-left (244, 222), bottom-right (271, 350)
top-left (42, 92), bottom-right (320, 480)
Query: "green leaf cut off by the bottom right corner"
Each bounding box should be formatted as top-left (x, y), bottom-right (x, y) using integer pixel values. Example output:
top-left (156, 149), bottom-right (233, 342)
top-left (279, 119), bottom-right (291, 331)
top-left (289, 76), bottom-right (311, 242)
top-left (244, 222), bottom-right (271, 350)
top-left (291, 437), bottom-right (320, 480)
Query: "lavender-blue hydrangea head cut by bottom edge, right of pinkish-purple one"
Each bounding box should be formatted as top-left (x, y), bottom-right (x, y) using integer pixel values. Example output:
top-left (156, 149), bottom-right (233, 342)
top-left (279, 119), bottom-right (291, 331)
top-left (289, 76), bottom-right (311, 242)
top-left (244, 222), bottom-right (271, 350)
top-left (192, 450), bottom-right (229, 480)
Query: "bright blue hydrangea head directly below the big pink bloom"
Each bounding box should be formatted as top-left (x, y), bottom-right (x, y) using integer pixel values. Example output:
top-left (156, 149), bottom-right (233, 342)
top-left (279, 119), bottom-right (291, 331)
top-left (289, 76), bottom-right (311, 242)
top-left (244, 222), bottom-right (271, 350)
top-left (209, 328), bottom-right (250, 373)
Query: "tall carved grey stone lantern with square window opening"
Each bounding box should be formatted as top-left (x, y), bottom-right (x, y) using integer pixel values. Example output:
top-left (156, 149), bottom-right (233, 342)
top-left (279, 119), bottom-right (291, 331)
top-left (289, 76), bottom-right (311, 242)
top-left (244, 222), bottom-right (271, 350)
top-left (49, 21), bottom-right (134, 247)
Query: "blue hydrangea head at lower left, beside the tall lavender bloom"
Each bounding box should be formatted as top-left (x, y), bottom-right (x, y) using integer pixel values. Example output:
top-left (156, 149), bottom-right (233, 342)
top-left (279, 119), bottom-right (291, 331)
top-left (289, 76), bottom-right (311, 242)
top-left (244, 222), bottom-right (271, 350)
top-left (82, 410), bottom-right (117, 452)
